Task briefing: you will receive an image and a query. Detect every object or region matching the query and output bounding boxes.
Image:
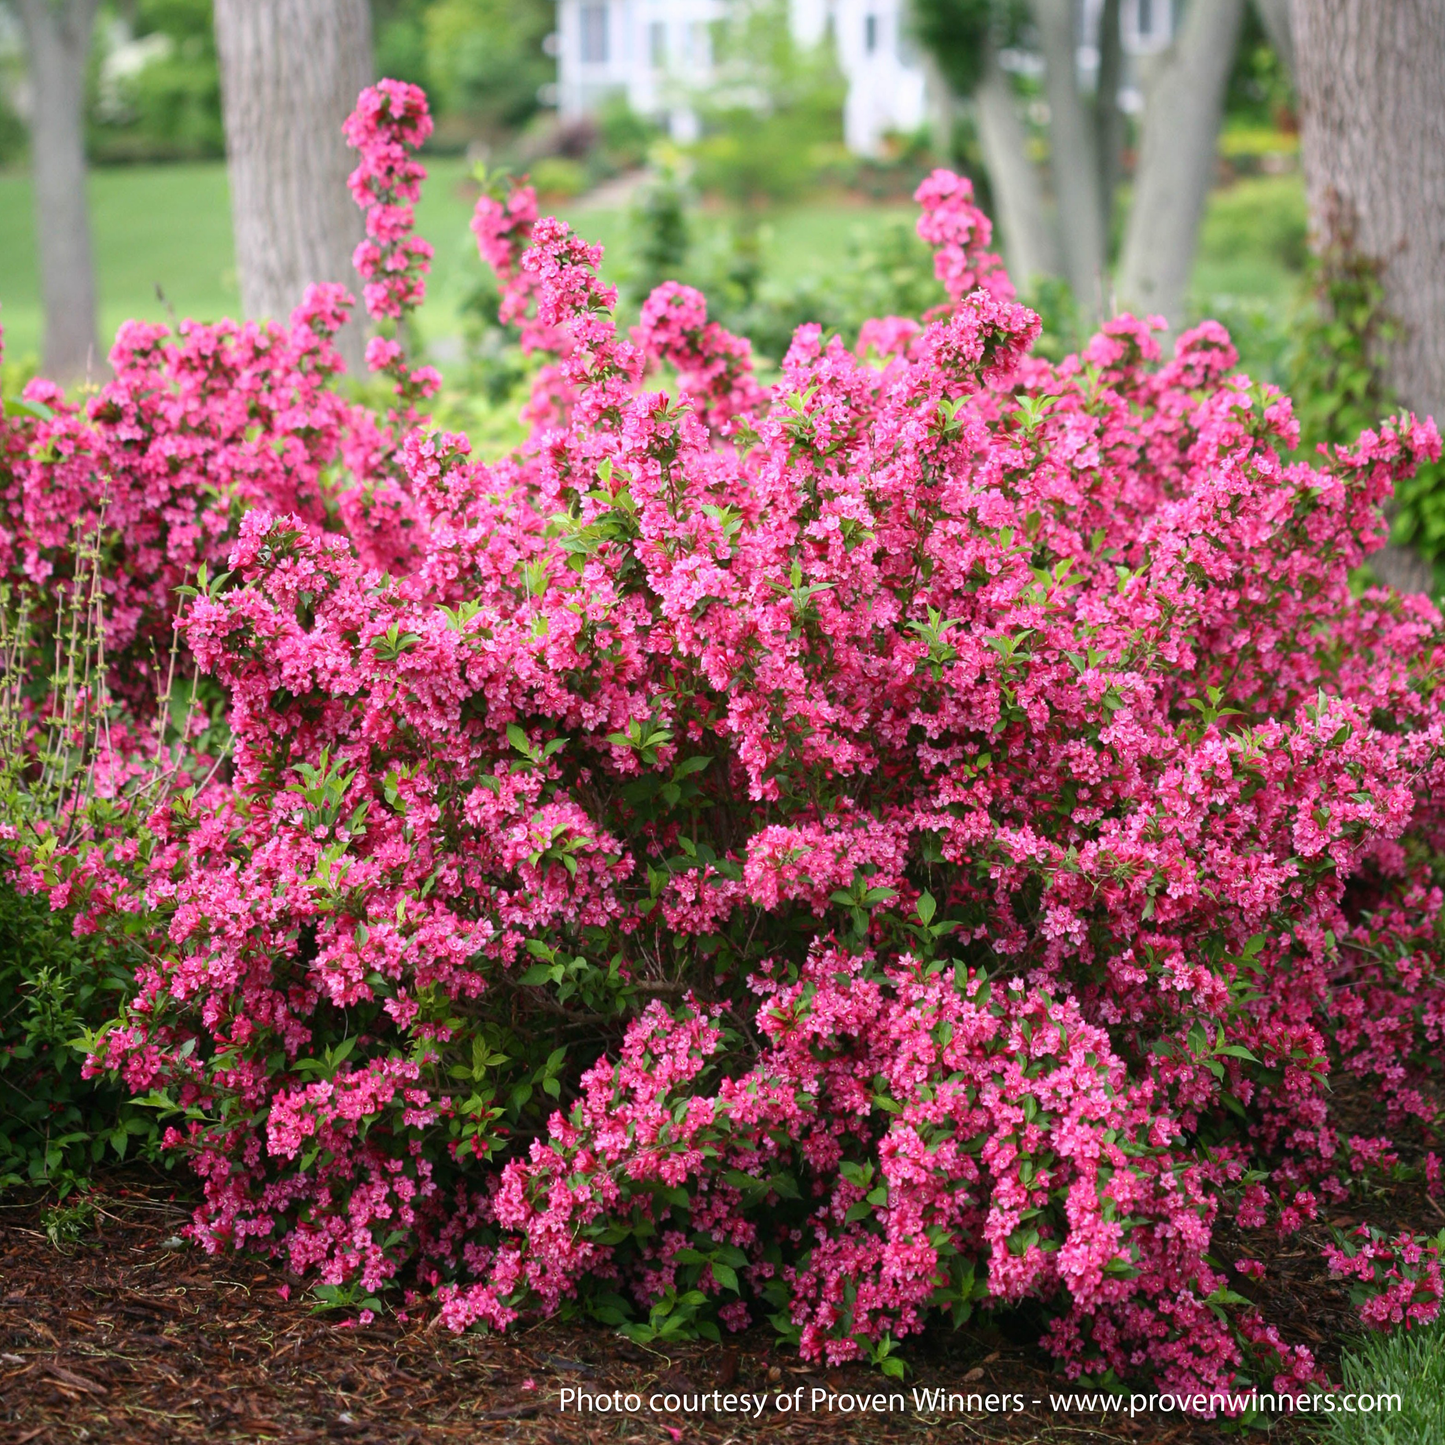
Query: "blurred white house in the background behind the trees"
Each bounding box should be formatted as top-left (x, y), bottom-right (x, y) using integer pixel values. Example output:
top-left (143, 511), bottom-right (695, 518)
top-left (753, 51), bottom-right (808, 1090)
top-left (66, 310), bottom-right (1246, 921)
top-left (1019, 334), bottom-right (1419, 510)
top-left (555, 0), bottom-right (1173, 155)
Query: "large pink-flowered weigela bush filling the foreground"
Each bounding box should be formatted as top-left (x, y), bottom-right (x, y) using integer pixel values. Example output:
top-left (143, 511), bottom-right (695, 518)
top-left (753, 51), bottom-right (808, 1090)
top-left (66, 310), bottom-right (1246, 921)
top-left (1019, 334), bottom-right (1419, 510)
top-left (8, 82), bottom-right (1445, 1393)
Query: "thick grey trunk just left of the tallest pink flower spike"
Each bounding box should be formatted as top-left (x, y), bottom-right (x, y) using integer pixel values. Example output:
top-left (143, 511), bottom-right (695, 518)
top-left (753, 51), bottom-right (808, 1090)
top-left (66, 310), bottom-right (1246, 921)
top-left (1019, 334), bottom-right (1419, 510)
top-left (215, 0), bottom-right (373, 371)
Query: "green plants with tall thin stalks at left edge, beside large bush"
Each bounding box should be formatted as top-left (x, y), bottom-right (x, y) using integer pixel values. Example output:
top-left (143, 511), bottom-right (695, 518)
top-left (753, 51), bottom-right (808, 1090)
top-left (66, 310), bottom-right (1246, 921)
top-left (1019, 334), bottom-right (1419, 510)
top-left (0, 534), bottom-right (192, 1199)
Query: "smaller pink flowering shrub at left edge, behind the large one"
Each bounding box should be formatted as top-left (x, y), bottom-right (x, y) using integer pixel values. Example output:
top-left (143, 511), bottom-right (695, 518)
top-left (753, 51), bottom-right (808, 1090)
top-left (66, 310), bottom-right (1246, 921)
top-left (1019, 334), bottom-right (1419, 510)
top-left (0, 286), bottom-right (406, 669)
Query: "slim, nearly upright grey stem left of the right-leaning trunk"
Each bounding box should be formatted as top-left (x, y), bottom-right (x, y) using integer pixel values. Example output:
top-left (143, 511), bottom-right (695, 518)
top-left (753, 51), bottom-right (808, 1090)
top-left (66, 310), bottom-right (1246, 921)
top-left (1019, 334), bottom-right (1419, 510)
top-left (1033, 0), bottom-right (1105, 315)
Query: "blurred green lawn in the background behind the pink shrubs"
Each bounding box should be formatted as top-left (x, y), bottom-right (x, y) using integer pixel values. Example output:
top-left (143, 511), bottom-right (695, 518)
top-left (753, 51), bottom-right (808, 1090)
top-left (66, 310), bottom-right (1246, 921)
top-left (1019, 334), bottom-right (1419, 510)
top-left (0, 158), bottom-right (1303, 372)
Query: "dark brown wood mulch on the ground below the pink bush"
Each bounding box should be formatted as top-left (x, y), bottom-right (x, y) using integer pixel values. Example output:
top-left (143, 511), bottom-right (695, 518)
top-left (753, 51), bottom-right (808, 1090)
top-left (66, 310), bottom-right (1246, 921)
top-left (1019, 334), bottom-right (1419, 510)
top-left (0, 1176), bottom-right (1348, 1445)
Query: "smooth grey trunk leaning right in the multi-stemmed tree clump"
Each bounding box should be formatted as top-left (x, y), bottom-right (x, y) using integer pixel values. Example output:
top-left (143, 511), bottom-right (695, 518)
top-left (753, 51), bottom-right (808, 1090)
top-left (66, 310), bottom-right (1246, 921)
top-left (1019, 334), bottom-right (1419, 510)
top-left (1118, 0), bottom-right (1244, 329)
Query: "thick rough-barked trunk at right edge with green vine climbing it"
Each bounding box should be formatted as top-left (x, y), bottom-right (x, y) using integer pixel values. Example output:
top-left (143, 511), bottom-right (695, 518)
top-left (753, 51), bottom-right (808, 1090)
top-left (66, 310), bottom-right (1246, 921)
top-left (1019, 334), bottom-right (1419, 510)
top-left (1292, 0), bottom-right (1445, 590)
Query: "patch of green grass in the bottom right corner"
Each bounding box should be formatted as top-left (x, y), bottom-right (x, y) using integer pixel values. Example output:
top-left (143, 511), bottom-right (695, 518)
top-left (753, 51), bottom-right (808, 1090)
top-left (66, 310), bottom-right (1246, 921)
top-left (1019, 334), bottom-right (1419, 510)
top-left (1319, 1324), bottom-right (1445, 1445)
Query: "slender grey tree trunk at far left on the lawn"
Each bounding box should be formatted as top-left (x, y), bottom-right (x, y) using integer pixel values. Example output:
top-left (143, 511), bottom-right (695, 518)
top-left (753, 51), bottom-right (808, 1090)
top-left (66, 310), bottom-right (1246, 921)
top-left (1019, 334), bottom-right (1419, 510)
top-left (20, 0), bottom-right (105, 381)
